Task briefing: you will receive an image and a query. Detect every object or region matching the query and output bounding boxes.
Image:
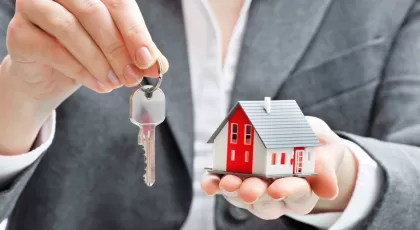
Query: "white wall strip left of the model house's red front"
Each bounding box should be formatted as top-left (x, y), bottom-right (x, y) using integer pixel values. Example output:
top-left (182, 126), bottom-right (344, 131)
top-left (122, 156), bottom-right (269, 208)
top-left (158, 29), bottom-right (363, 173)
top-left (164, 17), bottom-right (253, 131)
top-left (213, 123), bottom-right (229, 171)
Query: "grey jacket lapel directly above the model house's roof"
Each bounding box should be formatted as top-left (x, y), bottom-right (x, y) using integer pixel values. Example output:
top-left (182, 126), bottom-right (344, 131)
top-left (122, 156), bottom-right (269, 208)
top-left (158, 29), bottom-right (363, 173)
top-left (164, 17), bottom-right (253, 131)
top-left (230, 0), bottom-right (331, 107)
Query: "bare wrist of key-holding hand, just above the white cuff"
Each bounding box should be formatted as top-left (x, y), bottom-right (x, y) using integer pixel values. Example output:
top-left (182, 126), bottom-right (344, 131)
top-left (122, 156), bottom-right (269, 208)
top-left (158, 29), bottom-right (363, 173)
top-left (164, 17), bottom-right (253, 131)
top-left (0, 57), bottom-right (54, 155)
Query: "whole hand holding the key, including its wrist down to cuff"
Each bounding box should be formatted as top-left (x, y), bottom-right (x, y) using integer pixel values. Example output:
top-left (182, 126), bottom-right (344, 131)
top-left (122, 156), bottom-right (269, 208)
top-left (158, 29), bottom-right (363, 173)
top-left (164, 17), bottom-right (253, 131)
top-left (0, 0), bottom-right (168, 154)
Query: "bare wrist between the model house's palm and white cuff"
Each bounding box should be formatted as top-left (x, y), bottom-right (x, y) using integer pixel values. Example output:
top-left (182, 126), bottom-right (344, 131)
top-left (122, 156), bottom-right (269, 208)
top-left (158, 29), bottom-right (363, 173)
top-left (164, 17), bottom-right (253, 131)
top-left (314, 147), bottom-right (358, 213)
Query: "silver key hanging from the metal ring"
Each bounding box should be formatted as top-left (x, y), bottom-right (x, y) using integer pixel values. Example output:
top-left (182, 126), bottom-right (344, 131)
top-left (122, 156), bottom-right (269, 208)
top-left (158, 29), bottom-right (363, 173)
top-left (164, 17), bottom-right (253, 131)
top-left (130, 85), bottom-right (165, 187)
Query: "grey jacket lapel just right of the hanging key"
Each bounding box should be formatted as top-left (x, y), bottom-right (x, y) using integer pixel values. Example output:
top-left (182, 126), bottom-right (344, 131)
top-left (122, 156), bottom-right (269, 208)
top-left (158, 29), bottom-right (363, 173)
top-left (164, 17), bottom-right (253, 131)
top-left (138, 0), bottom-right (194, 175)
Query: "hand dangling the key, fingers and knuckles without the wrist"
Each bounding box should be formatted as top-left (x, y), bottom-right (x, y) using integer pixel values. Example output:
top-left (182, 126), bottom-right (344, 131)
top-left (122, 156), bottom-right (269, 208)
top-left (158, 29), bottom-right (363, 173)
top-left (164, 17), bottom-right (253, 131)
top-left (7, 0), bottom-right (168, 99)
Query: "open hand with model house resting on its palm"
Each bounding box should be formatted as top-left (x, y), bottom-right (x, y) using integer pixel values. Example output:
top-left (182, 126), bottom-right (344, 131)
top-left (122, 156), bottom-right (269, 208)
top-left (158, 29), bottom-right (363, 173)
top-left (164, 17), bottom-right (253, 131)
top-left (202, 117), bottom-right (357, 220)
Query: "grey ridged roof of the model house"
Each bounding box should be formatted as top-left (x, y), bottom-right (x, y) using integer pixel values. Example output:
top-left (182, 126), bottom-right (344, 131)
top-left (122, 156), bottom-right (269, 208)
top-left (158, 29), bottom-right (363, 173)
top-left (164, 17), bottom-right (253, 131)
top-left (208, 100), bottom-right (320, 149)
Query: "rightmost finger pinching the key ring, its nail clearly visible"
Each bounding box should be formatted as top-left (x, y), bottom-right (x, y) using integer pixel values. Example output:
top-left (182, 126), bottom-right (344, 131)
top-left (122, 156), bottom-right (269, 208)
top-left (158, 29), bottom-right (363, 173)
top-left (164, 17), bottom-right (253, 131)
top-left (102, 0), bottom-right (168, 73)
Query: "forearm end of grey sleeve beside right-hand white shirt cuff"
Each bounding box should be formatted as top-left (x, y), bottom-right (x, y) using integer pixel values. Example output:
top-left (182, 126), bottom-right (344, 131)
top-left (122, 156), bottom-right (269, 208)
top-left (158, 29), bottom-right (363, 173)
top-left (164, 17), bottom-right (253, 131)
top-left (337, 132), bottom-right (420, 230)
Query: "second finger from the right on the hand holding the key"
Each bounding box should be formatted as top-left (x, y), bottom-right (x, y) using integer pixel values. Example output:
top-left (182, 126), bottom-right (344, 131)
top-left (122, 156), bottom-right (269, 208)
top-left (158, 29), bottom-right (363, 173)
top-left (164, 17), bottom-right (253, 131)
top-left (56, 0), bottom-right (144, 86)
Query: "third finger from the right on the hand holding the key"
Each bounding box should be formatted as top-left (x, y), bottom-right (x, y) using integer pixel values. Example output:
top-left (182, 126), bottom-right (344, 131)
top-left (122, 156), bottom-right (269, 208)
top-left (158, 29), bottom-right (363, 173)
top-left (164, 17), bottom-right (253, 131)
top-left (23, 0), bottom-right (119, 92)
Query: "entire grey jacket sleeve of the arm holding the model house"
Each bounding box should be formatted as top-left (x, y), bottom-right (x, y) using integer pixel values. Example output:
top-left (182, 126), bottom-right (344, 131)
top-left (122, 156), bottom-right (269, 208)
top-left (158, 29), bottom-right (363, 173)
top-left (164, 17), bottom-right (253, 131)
top-left (340, 0), bottom-right (420, 230)
